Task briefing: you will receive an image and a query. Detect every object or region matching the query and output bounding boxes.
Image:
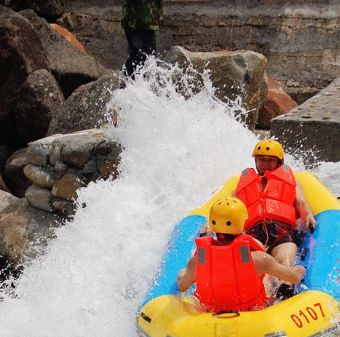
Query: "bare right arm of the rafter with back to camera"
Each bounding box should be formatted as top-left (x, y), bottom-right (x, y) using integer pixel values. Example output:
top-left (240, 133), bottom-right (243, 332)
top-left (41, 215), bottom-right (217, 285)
top-left (251, 251), bottom-right (306, 284)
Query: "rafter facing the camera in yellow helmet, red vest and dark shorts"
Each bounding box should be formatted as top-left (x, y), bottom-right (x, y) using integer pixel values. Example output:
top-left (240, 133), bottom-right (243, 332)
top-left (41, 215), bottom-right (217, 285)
top-left (233, 139), bottom-right (316, 266)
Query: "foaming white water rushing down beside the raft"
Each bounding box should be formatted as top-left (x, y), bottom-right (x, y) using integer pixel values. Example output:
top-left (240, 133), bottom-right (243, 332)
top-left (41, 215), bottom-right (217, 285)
top-left (0, 59), bottom-right (340, 337)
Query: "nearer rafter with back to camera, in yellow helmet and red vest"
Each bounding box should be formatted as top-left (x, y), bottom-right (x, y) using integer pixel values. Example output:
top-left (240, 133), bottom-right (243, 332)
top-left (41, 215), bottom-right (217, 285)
top-left (177, 197), bottom-right (305, 313)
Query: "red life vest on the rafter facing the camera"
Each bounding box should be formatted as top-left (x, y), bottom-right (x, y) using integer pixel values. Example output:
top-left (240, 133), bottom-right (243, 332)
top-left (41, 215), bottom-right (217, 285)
top-left (236, 165), bottom-right (296, 229)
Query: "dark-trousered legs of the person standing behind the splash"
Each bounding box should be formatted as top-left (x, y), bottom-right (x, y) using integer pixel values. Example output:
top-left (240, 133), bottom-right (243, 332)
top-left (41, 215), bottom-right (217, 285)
top-left (125, 28), bottom-right (156, 78)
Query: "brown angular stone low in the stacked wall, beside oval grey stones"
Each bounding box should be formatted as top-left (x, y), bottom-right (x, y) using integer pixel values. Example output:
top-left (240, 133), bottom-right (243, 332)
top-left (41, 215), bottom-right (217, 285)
top-left (52, 170), bottom-right (85, 201)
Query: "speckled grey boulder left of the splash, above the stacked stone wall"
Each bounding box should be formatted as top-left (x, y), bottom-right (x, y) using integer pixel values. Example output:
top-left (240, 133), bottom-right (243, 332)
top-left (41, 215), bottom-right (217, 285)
top-left (48, 73), bottom-right (119, 135)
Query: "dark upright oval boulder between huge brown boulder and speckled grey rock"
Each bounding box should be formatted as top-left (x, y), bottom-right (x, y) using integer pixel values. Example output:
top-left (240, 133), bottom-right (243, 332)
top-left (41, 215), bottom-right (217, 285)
top-left (15, 69), bottom-right (65, 142)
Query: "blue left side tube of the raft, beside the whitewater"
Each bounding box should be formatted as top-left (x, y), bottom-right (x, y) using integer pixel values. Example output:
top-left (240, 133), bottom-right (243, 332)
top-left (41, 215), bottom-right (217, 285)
top-left (142, 215), bottom-right (207, 306)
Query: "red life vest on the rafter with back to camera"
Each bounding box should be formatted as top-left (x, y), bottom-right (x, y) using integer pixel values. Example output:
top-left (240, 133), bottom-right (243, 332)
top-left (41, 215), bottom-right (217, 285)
top-left (195, 234), bottom-right (266, 313)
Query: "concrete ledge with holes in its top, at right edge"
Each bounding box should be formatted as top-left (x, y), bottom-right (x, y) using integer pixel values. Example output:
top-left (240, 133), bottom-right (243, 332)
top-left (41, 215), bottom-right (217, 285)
top-left (271, 78), bottom-right (340, 163)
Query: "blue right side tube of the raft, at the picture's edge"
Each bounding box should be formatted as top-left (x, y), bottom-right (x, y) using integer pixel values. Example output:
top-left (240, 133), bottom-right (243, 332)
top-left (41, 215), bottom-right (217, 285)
top-left (300, 210), bottom-right (340, 301)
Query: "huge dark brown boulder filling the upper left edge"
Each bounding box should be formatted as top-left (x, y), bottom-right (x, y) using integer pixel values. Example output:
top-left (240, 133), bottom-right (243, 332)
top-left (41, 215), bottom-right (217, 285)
top-left (0, 5), bottom-right (48, 147)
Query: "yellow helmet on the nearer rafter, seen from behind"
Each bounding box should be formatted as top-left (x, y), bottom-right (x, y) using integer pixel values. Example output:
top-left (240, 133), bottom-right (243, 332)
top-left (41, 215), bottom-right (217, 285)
top-left (209, 197), bottom-right (248, 235)
